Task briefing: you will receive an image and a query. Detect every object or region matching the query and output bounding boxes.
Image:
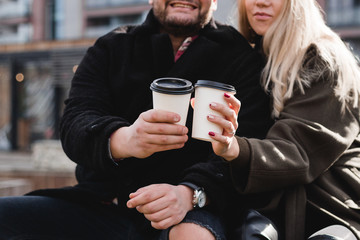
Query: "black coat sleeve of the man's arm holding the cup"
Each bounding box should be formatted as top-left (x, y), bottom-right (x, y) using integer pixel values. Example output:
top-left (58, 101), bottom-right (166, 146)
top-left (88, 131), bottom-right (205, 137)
top-left (60, 36), bottom-right (129, 171)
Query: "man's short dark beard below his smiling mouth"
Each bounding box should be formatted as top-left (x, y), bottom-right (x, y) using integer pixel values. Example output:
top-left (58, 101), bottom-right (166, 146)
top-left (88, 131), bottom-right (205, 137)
top-left (155, 9), bottom-right (210, 37)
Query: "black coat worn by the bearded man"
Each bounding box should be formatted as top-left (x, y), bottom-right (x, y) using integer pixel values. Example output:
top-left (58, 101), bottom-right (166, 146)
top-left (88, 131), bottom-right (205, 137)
top-left (29, 12), bottom-right (270, 233)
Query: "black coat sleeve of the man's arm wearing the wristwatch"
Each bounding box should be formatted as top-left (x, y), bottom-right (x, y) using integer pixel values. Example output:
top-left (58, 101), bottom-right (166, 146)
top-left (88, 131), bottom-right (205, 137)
top-left (183, 36), bottom-right (272, 216)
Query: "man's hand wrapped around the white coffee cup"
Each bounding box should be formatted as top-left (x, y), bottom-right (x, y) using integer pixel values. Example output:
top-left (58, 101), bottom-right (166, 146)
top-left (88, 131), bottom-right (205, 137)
top-left (110, 109), bottom-right (188, 158)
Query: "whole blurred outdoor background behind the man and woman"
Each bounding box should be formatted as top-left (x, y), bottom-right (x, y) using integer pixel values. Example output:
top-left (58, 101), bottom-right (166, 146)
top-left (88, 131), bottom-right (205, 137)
top-left (0, 0), bottom-right (360, 196)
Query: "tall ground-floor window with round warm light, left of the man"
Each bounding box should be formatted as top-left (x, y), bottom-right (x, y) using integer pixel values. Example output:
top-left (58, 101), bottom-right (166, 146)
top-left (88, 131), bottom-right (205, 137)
top-left (14, 58), bottom-right (55, 150)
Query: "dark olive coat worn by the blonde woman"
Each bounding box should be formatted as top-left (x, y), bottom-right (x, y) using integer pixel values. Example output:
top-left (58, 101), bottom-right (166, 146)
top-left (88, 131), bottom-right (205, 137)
top-left (230, 48), bottom-right (360, 240)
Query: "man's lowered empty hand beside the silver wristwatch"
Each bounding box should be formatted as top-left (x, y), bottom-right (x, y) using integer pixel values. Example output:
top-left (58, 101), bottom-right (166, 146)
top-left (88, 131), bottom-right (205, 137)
top-left (127, 184), bottom-right (193, 229)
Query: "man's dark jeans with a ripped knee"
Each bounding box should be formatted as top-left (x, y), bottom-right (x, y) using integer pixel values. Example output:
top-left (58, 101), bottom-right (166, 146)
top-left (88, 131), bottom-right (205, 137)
top-left (0, 196), bottom-right (226, 240)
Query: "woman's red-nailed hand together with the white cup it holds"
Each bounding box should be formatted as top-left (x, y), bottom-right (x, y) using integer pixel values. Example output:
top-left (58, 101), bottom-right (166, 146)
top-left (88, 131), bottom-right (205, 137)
top-left (191, 80), bottom-right (241, 161)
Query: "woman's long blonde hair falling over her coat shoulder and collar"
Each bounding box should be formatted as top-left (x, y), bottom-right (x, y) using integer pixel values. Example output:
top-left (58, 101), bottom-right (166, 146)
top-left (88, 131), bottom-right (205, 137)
top-left (238, 0), bottom-right (360, 117)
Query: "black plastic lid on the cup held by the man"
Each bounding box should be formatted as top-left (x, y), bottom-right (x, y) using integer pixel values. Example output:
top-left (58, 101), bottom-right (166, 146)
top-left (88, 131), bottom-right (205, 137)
top-left (150, 78), bottom-right (194, 95)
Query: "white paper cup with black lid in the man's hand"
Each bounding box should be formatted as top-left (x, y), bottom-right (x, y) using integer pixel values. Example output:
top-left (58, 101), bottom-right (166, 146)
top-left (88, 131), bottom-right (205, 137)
top-left (150, 77), bottom-right (194, 126)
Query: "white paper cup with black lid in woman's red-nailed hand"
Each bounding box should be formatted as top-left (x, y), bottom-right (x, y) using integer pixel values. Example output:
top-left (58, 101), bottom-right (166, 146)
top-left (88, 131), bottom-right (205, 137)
top-left (191, 80), bottom-right (236, 142)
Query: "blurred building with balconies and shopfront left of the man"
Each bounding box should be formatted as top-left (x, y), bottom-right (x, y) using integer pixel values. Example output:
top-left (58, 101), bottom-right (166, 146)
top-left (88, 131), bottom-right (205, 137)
top-left (0, 0), bottom-right (150, 150)
